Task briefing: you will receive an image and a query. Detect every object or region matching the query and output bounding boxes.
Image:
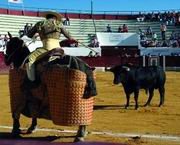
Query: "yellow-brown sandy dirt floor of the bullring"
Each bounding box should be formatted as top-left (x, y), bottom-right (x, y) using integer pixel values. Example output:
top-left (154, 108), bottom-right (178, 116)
top-left (0, 72), bottom-right (180, 145)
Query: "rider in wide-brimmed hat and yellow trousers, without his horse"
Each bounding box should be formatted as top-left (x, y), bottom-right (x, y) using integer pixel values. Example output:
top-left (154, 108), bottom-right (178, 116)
top-left (26, 11), bottom-right (72, 81)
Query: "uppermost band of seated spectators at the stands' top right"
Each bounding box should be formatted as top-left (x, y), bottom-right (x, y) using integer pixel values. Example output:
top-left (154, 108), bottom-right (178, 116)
top-left (137, 11), bottom-right (180, 25)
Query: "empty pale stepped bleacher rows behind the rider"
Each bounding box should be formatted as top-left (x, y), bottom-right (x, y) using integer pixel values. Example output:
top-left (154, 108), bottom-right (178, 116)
top-left (0, 14), bottom-right (179, 45)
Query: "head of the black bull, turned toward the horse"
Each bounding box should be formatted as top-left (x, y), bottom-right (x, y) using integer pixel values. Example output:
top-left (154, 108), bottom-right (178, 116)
top-left (106, 65), bottom-right (130, 84)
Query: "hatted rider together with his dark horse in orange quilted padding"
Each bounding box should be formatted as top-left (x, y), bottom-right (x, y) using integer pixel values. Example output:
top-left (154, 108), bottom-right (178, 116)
top-left (5, 12), bottom-right (97, 141)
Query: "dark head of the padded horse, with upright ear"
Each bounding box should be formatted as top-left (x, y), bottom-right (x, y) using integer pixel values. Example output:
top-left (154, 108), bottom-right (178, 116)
top-left (5, 32), bottom-right (30, 67)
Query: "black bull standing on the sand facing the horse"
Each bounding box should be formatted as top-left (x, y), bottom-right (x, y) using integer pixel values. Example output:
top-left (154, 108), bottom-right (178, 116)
top-left (107, 65), bottom-right (166, 109)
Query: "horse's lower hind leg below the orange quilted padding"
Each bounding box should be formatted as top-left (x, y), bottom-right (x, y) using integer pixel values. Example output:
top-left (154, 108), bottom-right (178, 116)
top-left (74, 125), bottom-right (87, 142)
